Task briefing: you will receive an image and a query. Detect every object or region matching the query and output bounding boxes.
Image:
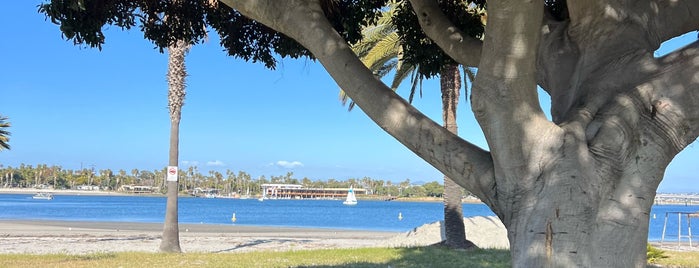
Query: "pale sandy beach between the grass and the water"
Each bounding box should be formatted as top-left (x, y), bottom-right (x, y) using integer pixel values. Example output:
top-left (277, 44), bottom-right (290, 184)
top-left (0, 217), bottom-right (508, 254)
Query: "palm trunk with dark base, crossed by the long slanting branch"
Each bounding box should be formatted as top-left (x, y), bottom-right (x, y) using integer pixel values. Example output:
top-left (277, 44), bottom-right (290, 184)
top-left (439, 64), bottom-right (475, 248)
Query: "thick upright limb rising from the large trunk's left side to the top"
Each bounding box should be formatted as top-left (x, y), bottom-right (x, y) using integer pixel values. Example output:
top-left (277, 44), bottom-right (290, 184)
top-left (471, 0), bottom-right (563, 195)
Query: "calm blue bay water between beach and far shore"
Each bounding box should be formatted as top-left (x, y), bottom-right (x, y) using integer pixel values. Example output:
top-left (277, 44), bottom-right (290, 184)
top-left (0, 194), bottom-right (699, 241)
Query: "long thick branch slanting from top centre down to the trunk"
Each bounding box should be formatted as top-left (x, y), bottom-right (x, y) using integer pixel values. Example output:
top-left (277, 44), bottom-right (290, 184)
top-left (222, 0), bottom-right (495, 204)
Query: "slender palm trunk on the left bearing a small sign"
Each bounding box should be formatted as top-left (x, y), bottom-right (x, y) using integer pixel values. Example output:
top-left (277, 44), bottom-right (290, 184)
top-left (160, 40), bottom-right (189, 252)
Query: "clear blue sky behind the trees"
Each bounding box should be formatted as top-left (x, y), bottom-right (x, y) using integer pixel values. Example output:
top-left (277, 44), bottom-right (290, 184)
top-left (0, 1), bottom-right (699, 192)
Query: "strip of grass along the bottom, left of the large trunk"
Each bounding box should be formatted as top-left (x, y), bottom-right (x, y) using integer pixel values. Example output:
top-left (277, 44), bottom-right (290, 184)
top-left (0, 247), bottom-right (510, 268)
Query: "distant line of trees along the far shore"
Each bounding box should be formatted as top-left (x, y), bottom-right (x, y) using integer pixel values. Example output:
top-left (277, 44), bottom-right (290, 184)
top-left (0, 164), bottom-right (460, 197)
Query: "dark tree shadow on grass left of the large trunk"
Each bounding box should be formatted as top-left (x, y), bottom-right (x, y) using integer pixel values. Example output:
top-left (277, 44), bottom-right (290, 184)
top-left (294, 245), bottom-right (511, 268)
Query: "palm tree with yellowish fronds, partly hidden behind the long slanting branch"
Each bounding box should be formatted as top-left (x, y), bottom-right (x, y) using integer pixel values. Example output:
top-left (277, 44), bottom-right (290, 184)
top-left (340, 1), bottom-right (474, 248)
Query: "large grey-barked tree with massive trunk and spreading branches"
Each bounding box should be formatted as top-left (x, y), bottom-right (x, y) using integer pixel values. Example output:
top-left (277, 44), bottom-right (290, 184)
top-left (222, 0), bottom-right (699, 267)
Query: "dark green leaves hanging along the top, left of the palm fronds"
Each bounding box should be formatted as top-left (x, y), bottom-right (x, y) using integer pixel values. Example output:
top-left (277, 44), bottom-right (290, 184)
top-left (38, 0), bottom-right (386, 69)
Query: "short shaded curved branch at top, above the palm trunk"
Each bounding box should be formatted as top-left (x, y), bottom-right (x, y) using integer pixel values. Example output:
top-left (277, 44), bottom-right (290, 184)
top-left (410, 0), bottom-right (483, 67)
